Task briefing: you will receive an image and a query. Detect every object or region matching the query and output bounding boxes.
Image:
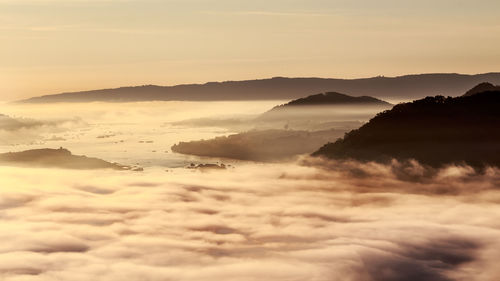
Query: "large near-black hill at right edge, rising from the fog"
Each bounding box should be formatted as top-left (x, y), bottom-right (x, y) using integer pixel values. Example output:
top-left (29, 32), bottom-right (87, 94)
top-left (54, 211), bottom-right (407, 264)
top-left (313, 86), bottom-right (500, 167)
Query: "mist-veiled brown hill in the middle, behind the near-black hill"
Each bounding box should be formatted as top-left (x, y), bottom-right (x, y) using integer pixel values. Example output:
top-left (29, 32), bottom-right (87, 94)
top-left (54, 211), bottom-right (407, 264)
top-left (172, 92), bottom-right (391, 162)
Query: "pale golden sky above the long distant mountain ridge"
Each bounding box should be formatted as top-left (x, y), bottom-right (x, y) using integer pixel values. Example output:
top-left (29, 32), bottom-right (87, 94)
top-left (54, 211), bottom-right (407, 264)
top-left (0, 0), bottom-right (500, 100)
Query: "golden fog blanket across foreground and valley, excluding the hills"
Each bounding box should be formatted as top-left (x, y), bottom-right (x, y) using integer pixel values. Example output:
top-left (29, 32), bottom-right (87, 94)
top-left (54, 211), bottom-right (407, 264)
top-left (0, 101), bottom-right (500, 281)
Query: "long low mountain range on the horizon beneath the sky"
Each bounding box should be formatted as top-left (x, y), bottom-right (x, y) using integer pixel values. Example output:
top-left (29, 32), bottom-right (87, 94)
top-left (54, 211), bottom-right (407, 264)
top-left (20, 73), bottom-right (500, 103)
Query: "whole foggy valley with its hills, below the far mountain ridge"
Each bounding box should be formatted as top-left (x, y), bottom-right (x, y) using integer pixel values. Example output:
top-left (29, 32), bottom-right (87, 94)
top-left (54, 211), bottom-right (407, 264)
top-left (0, 81), bottom-right (500, 281)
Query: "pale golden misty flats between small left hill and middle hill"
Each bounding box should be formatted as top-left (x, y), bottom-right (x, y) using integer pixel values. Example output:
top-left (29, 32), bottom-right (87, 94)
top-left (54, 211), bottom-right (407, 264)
top-left (0, 101), bottom-right (280, 167)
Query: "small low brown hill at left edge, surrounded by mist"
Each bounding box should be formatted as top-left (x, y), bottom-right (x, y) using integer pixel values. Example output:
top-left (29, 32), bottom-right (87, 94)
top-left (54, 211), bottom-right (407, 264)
top-left (0, 148), bottom-right (131, 170)
